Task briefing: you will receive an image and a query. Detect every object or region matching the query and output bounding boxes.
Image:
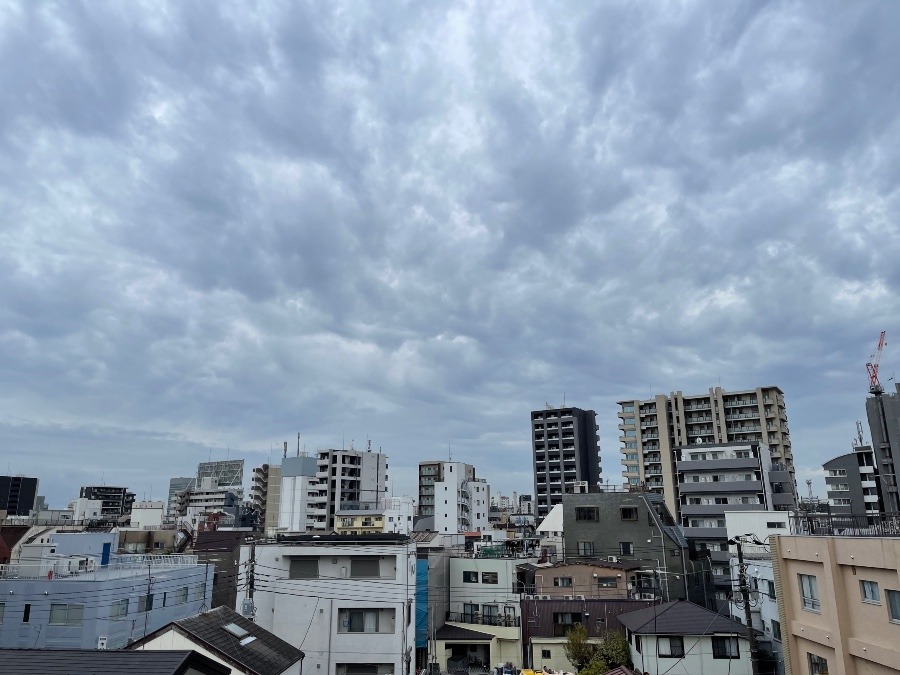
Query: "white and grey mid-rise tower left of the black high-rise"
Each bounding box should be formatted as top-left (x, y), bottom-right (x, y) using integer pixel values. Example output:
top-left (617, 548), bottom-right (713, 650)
top-left (419, 461), bottom-right (491, 534)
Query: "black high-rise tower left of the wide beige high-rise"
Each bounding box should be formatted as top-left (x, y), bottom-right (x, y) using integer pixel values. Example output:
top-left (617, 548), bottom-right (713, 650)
top-left (531, 406), bottom-right (601, 518)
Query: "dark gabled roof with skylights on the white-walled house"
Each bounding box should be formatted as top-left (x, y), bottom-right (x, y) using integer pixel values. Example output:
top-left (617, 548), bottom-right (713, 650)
top-left (129, 607), bottom-right (304, 675)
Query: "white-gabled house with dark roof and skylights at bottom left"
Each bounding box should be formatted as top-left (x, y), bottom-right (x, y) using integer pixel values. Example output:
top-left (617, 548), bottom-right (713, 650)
top-left (128, 607), bottom-right (304, 675)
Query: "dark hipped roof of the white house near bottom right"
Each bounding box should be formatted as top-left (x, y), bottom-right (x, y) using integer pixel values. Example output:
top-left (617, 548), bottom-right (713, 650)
top-left (619, 600), bottom-right (747, 637)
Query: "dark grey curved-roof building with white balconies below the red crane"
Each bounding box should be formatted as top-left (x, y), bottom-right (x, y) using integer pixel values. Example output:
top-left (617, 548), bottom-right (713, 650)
top-left (822, 445), bottom-right (885, 522)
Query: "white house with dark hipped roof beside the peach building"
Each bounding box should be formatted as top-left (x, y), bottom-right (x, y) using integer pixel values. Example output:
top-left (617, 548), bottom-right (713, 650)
top-left (619, 600), bottom-right (752, 675)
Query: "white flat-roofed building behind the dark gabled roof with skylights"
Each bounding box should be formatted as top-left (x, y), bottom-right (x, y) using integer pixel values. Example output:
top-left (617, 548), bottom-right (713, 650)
top-left (243, 534), bottom-right (416, 675)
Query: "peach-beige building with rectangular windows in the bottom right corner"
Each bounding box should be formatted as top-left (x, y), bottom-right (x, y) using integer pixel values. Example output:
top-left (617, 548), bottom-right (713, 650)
top-left (771, 536), bottom-right (900, 675)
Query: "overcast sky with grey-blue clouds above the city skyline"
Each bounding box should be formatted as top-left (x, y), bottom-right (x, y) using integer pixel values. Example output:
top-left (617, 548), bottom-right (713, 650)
top-left (0, 0), bottom-right (900, 507)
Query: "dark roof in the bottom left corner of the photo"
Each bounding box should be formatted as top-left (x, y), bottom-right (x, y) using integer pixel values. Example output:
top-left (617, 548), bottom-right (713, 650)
top-left (0, 649), bottom-right (232, 675)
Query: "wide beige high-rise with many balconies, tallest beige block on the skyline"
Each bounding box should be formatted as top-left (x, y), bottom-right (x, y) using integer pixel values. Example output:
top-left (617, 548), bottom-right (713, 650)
top-left (618, 387), bottom-right (794, 514)
